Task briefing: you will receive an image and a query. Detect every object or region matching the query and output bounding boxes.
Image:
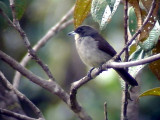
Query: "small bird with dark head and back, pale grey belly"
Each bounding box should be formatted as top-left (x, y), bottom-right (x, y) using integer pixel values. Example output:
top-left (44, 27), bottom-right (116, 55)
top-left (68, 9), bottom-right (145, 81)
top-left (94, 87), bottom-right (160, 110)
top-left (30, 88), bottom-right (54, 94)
top-left (68, 25), bottom-right (138, 86)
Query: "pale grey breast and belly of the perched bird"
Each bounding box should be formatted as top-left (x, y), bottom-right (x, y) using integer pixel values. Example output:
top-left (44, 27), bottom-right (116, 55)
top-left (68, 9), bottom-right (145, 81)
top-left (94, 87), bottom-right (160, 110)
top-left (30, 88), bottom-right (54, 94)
top-left (76, 36), bottom-right (111, 67)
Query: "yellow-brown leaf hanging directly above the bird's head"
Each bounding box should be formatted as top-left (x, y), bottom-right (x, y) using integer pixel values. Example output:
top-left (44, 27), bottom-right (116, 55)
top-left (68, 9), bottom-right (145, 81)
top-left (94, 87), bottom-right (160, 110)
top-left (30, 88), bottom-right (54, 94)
top-left (74, 0), bottom-right (92, 28)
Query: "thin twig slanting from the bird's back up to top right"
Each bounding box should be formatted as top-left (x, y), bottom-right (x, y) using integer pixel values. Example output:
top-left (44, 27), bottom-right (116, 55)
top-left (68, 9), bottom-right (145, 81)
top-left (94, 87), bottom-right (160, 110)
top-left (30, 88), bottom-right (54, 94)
top-left (116, 0), bottom-right (156, 58)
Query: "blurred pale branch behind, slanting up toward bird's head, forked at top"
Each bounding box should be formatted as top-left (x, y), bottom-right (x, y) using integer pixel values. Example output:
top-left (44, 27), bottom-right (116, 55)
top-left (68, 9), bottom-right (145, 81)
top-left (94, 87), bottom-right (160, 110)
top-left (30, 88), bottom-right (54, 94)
top-left (13, 6), bottom-right (74, 88)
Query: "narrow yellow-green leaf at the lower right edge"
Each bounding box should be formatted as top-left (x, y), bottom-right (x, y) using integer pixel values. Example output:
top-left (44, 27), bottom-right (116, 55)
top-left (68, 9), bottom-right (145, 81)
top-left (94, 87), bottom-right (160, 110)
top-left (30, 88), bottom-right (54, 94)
top-left (138, 87), bottom-right (160, 98)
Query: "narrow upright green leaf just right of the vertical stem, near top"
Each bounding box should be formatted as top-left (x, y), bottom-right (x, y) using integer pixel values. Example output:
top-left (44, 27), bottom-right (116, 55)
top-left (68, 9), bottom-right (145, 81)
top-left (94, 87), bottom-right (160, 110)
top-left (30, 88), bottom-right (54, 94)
top-left (128, 7), bottom-right (137, 35)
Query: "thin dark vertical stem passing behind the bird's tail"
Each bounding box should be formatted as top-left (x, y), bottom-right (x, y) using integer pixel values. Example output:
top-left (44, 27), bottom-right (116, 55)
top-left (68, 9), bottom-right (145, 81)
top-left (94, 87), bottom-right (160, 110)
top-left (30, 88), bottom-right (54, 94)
top-left (121, 0), bottom-right (129, 120)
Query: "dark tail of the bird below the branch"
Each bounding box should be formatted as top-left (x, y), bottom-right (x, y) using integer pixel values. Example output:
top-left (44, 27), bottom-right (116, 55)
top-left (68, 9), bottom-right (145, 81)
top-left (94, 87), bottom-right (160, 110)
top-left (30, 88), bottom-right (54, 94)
top-left (115, 68), bottom-right (138, 86)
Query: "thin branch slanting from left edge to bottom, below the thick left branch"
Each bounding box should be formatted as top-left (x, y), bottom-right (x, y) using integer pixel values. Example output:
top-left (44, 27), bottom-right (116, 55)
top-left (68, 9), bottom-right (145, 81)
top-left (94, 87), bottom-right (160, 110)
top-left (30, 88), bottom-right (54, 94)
top-left (0, 71), bottom-right (44, 119)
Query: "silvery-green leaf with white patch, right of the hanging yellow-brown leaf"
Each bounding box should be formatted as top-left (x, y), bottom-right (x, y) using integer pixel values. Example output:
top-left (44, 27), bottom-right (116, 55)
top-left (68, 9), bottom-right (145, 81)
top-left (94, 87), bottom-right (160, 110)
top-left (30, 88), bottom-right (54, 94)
top-left (91, 0), bottom-right (120, 30)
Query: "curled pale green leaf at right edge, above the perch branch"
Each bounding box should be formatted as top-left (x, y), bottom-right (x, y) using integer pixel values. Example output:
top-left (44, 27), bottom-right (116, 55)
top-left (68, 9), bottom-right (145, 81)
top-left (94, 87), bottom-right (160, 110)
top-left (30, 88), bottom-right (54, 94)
top-left (139, 22), bottom-right (160, 51)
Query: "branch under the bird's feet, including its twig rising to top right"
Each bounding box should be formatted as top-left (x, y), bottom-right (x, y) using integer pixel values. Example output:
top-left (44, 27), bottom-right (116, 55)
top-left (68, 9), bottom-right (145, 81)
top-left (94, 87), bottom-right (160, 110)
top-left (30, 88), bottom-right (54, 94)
top-left (70, 0), bottom-right (156, 109)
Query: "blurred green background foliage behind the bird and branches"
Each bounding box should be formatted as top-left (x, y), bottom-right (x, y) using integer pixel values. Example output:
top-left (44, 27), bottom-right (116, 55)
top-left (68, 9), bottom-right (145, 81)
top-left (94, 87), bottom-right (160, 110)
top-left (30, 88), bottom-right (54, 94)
top-left (0, 0), bottom-right (160, 120)
